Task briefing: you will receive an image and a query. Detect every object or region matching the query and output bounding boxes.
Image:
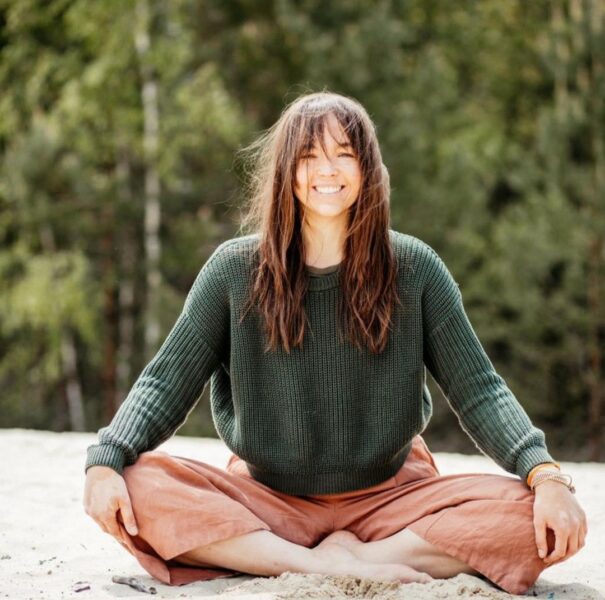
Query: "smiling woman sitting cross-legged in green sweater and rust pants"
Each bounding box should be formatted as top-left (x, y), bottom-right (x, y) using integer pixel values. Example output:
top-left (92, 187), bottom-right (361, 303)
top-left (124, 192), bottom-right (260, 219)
top-left (84, 92), bottom-right (587, 593)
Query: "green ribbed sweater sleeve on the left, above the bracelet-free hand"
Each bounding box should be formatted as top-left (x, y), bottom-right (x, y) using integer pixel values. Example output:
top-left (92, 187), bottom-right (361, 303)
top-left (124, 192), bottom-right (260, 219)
top-left (84, 247), bottom-right (229, 474)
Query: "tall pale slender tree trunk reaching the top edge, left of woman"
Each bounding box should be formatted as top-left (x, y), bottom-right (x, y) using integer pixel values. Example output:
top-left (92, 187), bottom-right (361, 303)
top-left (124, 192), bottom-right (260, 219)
top-left (134, 0), bottom-right (162, 360)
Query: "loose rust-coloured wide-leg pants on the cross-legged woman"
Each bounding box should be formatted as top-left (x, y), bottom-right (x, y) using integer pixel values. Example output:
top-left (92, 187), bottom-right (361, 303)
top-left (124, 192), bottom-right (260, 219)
top-left (113, 435), bottom-right (554, 594)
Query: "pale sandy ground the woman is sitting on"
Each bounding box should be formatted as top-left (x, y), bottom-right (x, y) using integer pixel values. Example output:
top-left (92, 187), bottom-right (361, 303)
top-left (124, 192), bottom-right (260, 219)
top-left (0, 429), bottom-right (605, 600)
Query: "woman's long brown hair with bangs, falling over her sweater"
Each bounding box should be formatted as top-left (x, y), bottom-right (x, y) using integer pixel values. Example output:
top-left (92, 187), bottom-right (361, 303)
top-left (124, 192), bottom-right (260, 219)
top-left (240, 91), bottom-right (401, 353)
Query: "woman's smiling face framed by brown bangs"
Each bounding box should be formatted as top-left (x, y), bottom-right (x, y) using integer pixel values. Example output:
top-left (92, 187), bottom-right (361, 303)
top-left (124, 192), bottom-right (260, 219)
top-left (294, 114), bottom-right (362, 217)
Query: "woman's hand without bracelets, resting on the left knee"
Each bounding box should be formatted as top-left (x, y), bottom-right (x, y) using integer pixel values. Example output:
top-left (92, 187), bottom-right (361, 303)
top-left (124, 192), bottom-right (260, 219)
top-left (84, 465), bottom-right (138, 543)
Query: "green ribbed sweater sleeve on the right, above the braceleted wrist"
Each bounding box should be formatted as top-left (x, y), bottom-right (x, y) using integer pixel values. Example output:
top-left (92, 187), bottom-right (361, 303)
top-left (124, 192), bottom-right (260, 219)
top-left (422, 245), bottom-right (553, 481)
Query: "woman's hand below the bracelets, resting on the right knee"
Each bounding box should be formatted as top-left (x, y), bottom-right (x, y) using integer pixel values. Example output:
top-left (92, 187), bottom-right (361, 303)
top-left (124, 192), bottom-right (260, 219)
top-left (534, 481), bottom-right (588, 566)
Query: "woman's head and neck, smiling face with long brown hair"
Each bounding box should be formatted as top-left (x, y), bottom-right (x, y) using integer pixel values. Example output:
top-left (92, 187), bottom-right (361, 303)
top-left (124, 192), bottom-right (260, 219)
top-left (236, 92), bottom-right (401, 353)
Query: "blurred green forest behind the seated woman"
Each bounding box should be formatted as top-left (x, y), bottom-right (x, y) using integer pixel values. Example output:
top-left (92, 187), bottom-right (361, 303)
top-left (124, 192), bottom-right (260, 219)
top-left (0, 0), bottom-right (605, 460)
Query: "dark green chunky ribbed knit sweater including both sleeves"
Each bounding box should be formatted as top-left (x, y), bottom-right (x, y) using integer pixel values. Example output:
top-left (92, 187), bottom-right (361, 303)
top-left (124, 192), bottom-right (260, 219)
top-left (85, 230), bottom-right (553, 495)
